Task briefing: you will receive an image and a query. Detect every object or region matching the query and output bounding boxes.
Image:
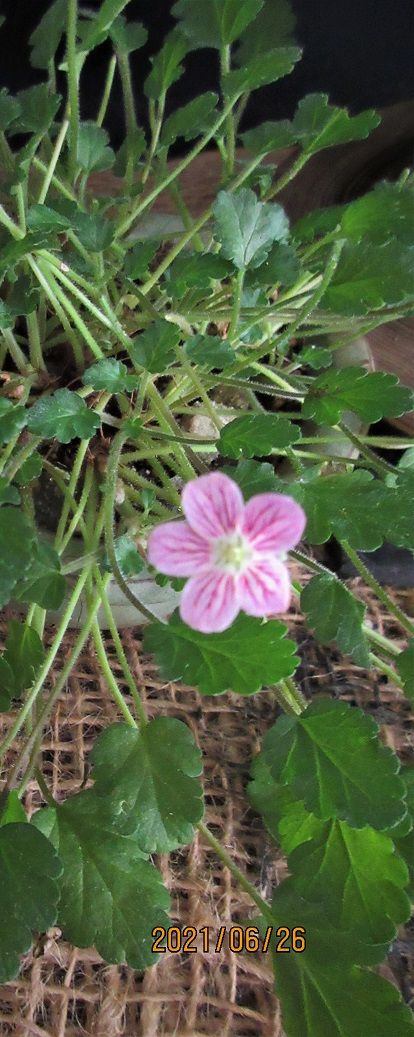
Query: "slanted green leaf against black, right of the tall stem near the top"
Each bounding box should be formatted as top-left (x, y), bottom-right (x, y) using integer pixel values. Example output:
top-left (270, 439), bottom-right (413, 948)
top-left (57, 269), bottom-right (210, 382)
top-left (223, 47), bottom-right (302, 97)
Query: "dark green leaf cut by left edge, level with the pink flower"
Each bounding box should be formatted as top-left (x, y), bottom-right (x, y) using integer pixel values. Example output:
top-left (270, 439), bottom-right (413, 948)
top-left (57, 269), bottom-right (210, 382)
top-left (0, 506), bottom-right (35, 608)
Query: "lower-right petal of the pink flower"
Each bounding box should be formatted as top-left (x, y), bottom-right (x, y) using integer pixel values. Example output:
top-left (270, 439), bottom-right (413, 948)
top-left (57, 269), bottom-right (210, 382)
top-left (238, 558), bottom-right (291, 616)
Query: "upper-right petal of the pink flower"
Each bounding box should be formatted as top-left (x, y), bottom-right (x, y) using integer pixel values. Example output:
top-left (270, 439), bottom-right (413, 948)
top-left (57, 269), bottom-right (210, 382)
top-left (241, 494), bottom-right (306, 554)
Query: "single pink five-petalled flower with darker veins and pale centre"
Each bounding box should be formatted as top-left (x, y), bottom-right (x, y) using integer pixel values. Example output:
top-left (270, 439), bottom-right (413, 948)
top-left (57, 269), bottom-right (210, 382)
top-left (148, 472), bottom-right (306, 634)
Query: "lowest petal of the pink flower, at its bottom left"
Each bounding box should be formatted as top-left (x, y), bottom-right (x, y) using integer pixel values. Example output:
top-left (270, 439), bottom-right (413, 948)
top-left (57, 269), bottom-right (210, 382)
top-left (180, 569), bottom-right (240, 634)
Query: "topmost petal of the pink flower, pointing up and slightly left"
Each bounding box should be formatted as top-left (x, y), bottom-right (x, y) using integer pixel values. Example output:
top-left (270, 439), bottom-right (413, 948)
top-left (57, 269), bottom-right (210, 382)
top-left (182, 472), bottom-right (244, 540)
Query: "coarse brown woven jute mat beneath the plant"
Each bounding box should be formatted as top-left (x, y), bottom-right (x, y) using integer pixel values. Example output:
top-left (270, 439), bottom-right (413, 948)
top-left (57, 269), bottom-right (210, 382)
top-left (0, 573), bottom-right (414, 1037)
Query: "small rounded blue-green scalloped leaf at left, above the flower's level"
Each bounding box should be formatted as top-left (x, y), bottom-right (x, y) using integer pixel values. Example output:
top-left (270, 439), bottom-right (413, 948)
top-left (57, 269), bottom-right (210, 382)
top-left (27, 389), bottom-right (101, 443)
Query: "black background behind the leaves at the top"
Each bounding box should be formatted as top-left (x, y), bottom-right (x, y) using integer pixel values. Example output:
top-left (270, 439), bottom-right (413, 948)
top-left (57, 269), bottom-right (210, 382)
top-left (0, 0), bottom-right (414, 146)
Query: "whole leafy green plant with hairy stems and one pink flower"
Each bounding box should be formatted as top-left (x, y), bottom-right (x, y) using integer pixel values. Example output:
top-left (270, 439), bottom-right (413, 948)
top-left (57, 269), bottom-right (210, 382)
top-left (0, 0), bottom-right (414, 1037)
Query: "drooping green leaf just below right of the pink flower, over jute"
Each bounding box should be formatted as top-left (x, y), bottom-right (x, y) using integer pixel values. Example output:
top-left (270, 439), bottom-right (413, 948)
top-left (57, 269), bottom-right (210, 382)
top-left (301, 573), bottom-right (370, 668)
